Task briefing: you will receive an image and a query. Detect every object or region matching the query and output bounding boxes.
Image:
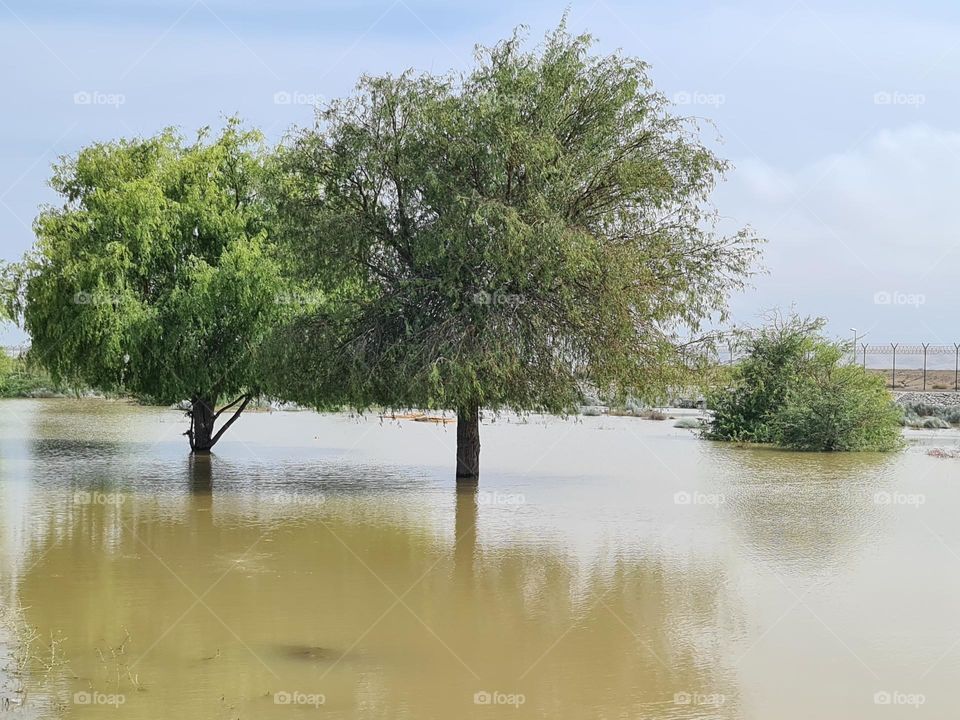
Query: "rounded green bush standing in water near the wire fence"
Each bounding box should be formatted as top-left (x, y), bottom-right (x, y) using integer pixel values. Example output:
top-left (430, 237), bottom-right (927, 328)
top-left (707, 315), bottom-right (901, 451)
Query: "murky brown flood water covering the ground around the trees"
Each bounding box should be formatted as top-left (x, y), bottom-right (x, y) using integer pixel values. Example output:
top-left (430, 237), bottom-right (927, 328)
top-left (0, 400), bottom-right (960, 720)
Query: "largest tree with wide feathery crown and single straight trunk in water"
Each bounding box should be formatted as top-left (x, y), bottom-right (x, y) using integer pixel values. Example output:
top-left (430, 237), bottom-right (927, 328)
top-left (268, 25), bottom-right (756, 478)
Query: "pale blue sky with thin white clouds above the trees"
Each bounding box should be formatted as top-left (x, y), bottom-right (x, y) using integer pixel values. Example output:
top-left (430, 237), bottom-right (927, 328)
top-left (0, 0), bottom-right (960, 344)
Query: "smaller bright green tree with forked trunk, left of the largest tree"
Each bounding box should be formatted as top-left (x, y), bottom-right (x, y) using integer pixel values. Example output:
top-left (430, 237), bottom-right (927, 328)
top-left (21, 119), bottom-right (284, 453)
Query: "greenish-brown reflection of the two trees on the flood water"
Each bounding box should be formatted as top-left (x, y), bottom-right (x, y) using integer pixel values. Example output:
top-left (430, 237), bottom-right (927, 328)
top-left (4, 402), bottom-right (738, 718)
